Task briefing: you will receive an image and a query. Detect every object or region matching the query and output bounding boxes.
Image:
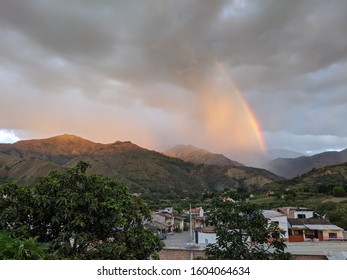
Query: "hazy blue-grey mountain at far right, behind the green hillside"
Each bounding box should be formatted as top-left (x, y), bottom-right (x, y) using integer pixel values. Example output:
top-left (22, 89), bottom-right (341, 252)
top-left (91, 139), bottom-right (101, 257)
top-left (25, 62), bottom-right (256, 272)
top-left (265, 149), bottom-right (347, 179)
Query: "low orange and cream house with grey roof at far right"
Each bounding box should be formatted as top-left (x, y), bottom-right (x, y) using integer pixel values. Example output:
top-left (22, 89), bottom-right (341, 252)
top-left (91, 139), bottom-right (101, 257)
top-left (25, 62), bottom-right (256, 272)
top-left (288, 217), bottom-right (344, 242)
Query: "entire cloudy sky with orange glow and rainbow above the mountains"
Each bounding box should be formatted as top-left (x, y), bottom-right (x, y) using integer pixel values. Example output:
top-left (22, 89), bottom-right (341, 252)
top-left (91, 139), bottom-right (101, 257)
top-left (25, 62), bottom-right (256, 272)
top-left (0, 0), bottom-right (347, 163)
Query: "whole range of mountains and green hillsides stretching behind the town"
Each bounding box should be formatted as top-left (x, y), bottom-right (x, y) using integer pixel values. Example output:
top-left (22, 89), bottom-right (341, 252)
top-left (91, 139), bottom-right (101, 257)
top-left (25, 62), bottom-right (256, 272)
top-left (0, 134), bottom-right (347, 228)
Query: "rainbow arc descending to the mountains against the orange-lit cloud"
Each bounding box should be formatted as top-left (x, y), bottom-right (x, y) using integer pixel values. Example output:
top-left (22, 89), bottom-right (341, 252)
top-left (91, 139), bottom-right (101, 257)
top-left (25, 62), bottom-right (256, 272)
top-left (215, 60), bottom-right (267, 154)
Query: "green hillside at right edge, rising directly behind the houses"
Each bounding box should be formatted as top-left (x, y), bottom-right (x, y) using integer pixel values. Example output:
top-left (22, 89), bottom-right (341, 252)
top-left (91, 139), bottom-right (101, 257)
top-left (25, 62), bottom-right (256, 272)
top-left (251, 163), bottom-right (347, 230)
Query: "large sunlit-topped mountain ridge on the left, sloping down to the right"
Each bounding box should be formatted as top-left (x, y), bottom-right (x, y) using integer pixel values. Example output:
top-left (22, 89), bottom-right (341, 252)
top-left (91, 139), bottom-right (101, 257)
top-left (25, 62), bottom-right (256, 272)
top-left (0, 135), bottom-right (282, 202)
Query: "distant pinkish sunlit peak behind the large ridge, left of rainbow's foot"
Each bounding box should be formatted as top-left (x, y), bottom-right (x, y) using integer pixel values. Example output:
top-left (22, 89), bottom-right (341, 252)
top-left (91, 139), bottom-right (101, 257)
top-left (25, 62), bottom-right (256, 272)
top-left (165, 145), bottom-right (244, 166)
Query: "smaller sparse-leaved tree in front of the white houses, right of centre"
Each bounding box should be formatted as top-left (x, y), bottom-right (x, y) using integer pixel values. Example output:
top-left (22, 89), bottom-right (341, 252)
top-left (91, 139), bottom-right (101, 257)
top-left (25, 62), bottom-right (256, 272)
top-left (206, 190), bottom-right (291, 260)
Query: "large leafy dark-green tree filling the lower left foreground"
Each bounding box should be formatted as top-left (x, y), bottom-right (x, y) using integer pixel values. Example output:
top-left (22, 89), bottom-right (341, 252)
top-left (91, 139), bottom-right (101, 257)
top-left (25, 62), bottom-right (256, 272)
top-left (0, 161), bottom-right (163, 260)
